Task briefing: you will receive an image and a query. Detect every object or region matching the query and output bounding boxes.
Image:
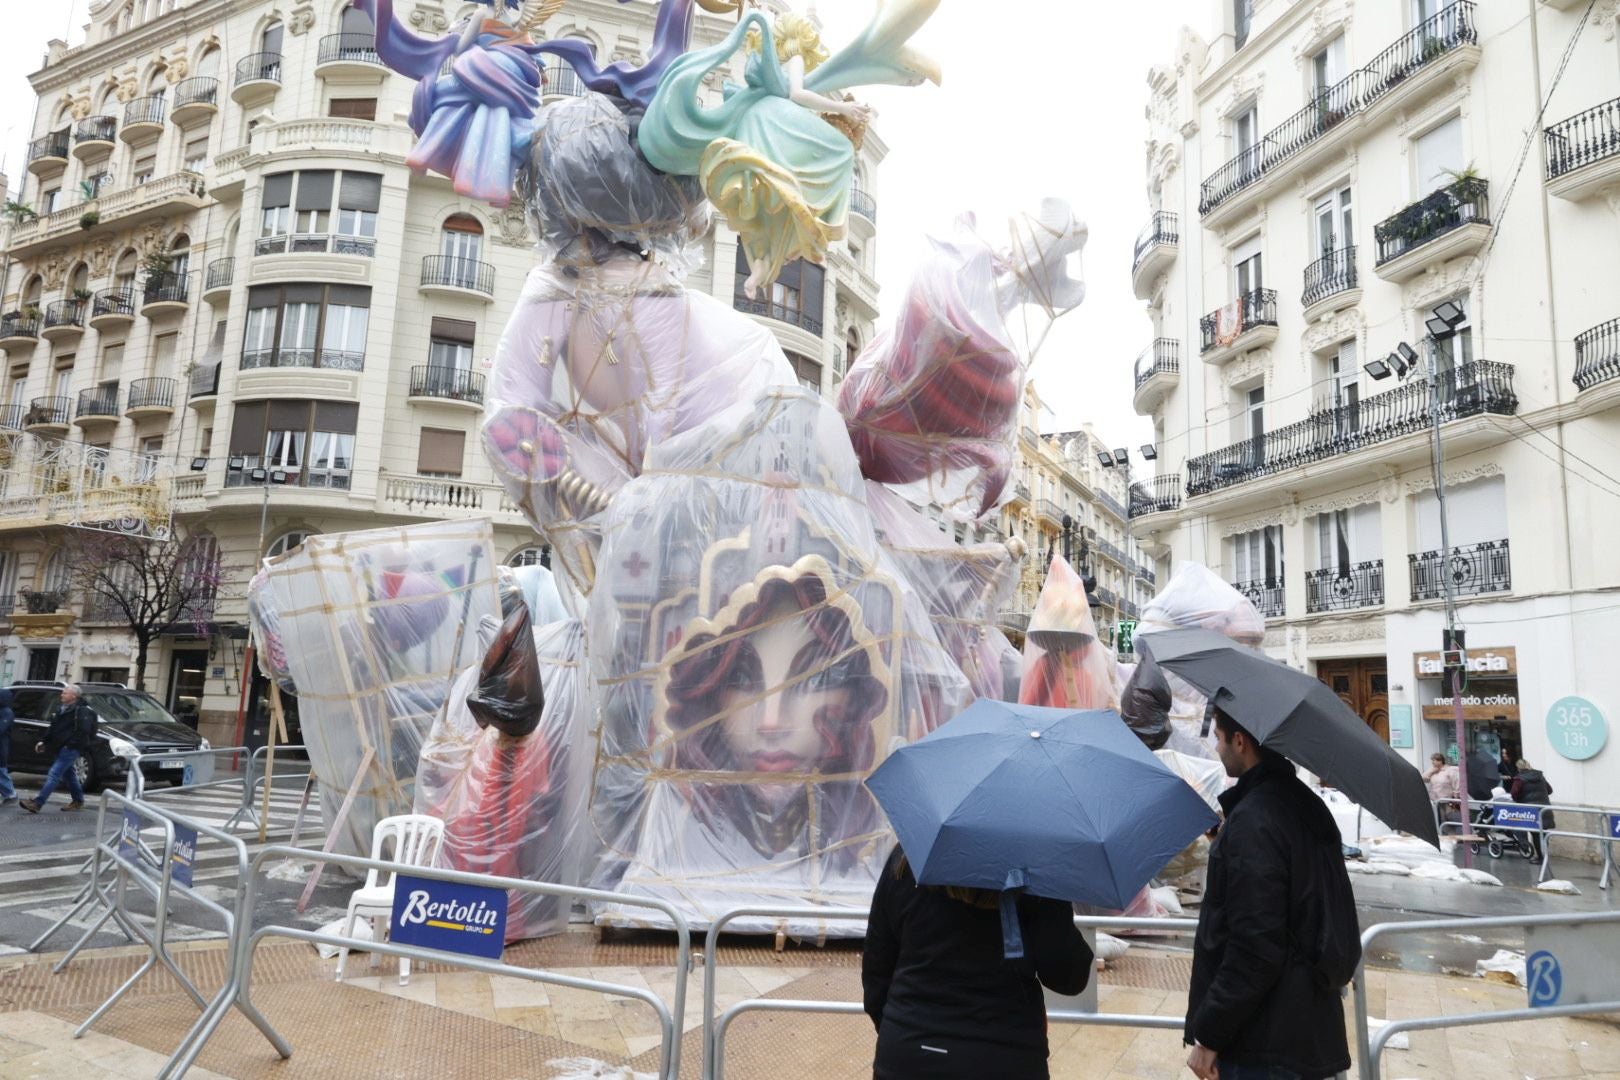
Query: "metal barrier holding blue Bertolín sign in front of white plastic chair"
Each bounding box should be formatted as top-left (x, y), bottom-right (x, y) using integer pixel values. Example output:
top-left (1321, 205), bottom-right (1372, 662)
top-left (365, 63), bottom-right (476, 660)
top-left (159, 844), bottom-right (692, 1080)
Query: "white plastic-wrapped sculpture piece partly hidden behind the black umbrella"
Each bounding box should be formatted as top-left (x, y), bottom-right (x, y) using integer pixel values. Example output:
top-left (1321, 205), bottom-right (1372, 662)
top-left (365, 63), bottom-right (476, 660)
top-left (1126, 562), bottom-right (1265, 758)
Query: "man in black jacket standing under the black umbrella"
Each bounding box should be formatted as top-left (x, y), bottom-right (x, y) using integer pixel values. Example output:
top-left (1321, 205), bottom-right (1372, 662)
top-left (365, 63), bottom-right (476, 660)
top-left (1183, 709), bottom-right (1353, 1080)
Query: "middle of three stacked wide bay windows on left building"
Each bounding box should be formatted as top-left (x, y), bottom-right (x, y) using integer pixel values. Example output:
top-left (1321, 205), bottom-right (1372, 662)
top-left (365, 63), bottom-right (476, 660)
top-left (241, 285), bottom-right (371, 371)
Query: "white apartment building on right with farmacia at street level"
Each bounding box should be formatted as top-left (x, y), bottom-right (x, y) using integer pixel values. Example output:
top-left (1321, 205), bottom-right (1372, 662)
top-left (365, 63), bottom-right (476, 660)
top-left (1131, 0), bottom-right (1620, 805)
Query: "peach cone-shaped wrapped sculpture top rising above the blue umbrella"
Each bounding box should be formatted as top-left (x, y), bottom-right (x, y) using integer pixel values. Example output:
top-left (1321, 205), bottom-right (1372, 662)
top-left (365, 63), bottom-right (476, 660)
top-left (1017, 555), bottom-right (1119, 711)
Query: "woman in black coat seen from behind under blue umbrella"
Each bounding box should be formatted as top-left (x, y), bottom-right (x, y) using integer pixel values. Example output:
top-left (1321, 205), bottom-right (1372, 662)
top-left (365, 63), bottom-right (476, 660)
top-left (860, 848), bottom-right (1094, 1080)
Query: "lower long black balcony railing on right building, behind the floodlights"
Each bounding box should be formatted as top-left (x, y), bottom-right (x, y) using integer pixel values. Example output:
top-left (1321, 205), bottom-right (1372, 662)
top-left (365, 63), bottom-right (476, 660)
top-left (1187, 359), bottom-right (1518, 495)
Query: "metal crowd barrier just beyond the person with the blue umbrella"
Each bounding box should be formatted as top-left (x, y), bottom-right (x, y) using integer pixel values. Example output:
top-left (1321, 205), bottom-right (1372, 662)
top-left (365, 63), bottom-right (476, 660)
top-left (701, 907), bottom-right (1199, 1080)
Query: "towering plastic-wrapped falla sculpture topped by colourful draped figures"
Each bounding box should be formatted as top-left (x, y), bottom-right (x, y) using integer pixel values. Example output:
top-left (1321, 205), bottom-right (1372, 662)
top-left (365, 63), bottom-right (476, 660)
top-left (254, 0), bottom-right (1085, 934)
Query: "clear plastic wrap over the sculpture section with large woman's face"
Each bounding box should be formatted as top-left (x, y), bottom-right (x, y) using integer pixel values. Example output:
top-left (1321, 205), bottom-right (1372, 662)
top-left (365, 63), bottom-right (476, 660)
top-left (586, 387), bottom-right (970, 934)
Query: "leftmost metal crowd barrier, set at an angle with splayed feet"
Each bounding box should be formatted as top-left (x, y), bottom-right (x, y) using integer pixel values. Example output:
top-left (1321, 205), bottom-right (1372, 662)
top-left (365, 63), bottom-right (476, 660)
top-left (29, 790), bottom-right (278, 1080)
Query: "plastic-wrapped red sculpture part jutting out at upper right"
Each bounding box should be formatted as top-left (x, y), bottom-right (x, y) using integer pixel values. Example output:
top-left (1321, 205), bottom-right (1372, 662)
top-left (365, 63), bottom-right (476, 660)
top-left (838, 199), bottom-right (1085, 520)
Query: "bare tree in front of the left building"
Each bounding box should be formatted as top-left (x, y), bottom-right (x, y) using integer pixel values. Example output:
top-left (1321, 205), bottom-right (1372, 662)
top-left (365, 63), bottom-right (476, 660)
top-left (68, 531), bottom-right (225, 690)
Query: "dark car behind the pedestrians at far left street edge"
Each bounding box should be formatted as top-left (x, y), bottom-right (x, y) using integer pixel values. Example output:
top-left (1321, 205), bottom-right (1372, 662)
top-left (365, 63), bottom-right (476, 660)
top-left (8, 683), bottom-right (211, 792)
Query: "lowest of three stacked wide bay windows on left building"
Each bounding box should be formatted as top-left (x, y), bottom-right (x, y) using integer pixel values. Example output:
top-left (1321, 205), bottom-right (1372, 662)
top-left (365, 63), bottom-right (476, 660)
top-left (225, 402), bottom-right (360, 489)
